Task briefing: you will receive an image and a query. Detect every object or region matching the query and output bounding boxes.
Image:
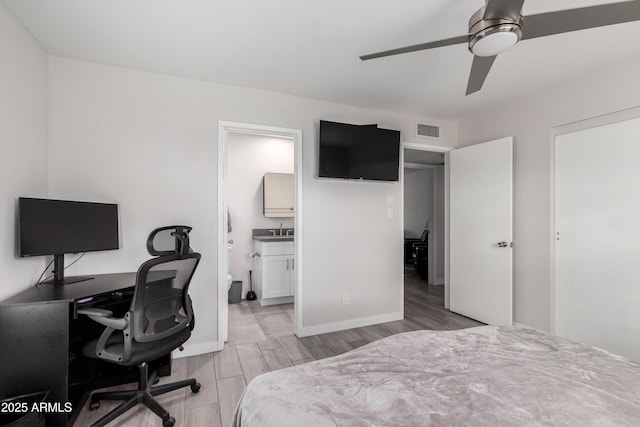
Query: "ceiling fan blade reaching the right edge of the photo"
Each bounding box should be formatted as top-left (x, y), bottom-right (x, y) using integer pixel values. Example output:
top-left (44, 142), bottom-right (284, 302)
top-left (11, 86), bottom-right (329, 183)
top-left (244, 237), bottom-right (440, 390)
top-left (522, 0), bottom-right (640, 40)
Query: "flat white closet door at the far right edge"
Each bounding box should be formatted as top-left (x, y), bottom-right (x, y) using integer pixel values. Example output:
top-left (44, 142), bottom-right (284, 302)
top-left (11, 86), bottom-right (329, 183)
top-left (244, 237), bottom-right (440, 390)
top-left (554, 119), bottom-right (640, 361)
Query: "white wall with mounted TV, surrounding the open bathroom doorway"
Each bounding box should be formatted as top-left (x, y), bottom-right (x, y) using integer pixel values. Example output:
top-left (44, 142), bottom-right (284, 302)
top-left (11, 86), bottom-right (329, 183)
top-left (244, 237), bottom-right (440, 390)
top-left (50, 57), bottom-right (457, 350)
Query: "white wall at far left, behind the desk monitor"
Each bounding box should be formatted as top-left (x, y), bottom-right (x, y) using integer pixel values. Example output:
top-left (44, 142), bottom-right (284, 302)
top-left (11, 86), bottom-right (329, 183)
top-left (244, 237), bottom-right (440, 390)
top-left (0, 3), bottom-right (49, 300)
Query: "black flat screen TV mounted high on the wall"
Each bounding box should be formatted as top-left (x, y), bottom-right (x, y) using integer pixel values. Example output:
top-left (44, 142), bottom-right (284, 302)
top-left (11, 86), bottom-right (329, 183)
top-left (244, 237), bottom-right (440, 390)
top-left (318, 120), bottom-right (400, 181)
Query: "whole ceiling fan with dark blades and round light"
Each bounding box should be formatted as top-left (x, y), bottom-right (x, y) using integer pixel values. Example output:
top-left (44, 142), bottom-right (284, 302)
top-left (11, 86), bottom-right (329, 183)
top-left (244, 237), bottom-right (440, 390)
top-left (360, 0), bottom-right (640, 95)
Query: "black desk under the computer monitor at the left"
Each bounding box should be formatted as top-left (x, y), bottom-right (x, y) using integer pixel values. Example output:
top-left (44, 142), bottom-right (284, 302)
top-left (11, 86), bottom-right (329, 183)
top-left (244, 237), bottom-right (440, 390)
top-left (0, 273), bottom-right (136, 427)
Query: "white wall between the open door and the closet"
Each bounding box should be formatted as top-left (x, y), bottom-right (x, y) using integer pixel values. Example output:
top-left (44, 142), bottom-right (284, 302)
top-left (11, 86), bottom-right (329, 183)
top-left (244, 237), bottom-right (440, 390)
top-left (458, 54), bottom-right (640, 331)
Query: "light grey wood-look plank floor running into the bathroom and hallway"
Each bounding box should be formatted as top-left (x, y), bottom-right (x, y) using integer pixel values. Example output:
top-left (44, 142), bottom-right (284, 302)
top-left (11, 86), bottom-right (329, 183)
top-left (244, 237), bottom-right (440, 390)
top-left (74, 269), bottom-right (481, 427)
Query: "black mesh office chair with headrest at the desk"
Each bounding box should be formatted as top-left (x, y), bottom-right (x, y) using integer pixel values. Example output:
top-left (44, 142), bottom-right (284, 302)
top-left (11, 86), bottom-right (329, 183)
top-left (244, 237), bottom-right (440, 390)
top-left (78, 225), bottom-right (200, 427)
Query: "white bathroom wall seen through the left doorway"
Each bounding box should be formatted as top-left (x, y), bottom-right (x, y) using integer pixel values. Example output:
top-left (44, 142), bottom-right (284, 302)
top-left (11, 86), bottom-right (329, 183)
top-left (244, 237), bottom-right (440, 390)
top-left (227, 132), bottom-right (294, 298)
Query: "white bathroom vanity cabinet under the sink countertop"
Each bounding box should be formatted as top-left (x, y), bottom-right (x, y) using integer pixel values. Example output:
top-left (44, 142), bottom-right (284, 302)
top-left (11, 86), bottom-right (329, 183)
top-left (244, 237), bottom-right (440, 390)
top-left (256, 240), bottom-right (295, 305)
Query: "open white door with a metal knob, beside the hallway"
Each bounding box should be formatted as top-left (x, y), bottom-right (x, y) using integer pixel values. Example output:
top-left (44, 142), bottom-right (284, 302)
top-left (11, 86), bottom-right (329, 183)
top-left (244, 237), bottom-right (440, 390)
top-left (449, 137), bottom-right (513, 325)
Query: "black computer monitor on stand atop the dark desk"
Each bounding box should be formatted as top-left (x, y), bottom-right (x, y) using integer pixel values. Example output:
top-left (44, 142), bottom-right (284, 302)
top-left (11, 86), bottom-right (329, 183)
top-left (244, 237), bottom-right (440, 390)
top-left (18, 197), bottom-right (120, 284)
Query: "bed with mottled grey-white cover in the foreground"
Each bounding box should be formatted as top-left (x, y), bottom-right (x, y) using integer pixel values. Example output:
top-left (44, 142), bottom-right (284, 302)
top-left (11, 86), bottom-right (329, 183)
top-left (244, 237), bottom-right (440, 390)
top-left (234, 326), bottom-right (640, 427)
